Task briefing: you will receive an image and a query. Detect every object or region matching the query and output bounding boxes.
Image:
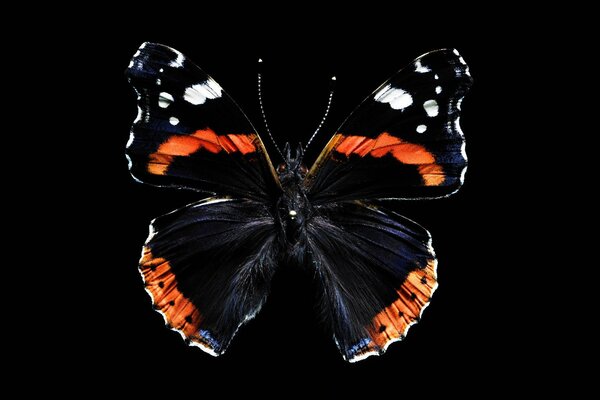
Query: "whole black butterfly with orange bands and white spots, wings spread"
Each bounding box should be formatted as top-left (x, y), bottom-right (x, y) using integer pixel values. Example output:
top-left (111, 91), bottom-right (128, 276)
top-left (126, 43), bottom-right (472, 362)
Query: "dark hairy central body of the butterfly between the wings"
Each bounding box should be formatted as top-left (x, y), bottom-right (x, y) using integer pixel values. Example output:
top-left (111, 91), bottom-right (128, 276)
top-left (277, 143), bottom-right (310, 245)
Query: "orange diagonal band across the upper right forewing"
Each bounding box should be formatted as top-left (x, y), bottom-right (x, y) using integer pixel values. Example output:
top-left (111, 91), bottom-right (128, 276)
top-left (335, 132), bottom-right (445, 186)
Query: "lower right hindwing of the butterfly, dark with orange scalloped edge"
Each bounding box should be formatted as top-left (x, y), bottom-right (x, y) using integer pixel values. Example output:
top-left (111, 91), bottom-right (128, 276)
top-left (307, 202), bottom-right (437, 362)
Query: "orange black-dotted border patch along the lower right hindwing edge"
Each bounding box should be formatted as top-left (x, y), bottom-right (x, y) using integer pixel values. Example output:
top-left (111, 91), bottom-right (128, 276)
top-left (369, 260), bottom-right (436, 349)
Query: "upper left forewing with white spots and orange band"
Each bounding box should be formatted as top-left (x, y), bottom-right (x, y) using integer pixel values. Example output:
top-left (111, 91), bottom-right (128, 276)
top-left (126, 43), bottom-right (278, 199)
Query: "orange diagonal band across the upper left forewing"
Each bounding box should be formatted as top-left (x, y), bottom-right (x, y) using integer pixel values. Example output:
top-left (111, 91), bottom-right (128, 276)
top-left (147, 128), bottom-right (256, 175)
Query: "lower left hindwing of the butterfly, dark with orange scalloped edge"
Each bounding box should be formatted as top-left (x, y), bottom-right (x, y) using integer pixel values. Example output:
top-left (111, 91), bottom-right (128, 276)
top-left (140, 198), bottom-right (277, 355)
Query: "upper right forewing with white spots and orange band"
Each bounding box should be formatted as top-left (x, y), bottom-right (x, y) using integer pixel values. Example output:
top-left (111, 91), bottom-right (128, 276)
top-left (305, 49), bottom-right (472, 204)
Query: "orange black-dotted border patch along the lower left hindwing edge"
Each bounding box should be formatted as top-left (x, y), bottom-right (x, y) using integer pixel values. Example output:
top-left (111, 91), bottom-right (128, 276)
top-left (140, 247), bottom-right (201, 338)
